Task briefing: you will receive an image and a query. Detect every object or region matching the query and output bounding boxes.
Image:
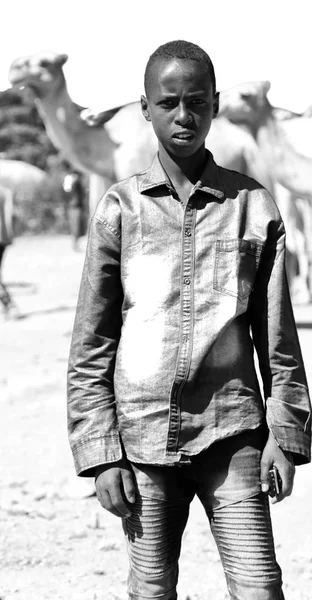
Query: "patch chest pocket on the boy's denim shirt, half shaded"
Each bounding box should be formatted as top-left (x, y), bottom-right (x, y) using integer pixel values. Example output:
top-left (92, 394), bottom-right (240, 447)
top-left (213, 239), bottom-right (263, 301)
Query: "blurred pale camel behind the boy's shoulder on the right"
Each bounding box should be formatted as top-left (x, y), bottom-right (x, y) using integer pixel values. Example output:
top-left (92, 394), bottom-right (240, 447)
top-left (220, 82), bottom-right (312, 302)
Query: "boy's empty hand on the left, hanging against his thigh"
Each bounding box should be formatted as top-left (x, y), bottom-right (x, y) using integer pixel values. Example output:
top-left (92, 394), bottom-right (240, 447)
top-left (95, 458), bottom-right (135, 517)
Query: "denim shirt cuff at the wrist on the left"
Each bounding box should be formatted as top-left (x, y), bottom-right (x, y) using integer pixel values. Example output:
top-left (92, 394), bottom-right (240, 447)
top-left (72, 435), bottom-right (123, 477)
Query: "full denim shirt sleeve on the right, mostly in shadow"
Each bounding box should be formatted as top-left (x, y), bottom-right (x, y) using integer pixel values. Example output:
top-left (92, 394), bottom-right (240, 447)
top-left (250, 220), bottom-right (311, 464)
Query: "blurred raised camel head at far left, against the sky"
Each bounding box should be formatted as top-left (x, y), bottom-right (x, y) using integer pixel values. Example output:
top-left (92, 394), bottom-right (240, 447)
top-left (9, 52), bottom-right (68, 98)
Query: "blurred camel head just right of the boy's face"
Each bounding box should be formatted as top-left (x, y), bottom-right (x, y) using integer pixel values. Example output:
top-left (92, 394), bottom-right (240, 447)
top-left (219, 81), bottom-right (270, 125)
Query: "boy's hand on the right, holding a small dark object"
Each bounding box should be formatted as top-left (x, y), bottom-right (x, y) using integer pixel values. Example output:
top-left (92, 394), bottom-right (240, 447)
top-left (260, 432), bottom-right (296, 504)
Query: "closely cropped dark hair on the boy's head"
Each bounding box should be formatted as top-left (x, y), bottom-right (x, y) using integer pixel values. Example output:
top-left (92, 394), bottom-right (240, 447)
top-left (144, 40), bottom-right (216, 95)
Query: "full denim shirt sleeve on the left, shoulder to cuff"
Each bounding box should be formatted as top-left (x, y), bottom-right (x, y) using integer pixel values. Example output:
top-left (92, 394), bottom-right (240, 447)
top-left (67, 195), bottom-right (123, 476)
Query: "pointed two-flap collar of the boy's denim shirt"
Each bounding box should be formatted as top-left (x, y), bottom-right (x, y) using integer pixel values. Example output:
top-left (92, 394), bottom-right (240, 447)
top-left (139, 150), bottom-right (225, 200)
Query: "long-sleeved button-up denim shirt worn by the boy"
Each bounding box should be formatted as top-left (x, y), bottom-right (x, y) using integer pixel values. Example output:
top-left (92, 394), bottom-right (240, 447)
top-left (68, 152), bottom-right (311, 476)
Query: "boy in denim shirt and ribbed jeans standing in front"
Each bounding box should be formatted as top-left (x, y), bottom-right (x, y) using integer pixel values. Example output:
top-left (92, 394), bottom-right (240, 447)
top-left (68, 41), bottom-right (310, 600)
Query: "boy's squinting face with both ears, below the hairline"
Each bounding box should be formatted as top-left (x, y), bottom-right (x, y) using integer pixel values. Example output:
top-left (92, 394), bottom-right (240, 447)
top-left (141, 59), bottom-right (219, 158)
